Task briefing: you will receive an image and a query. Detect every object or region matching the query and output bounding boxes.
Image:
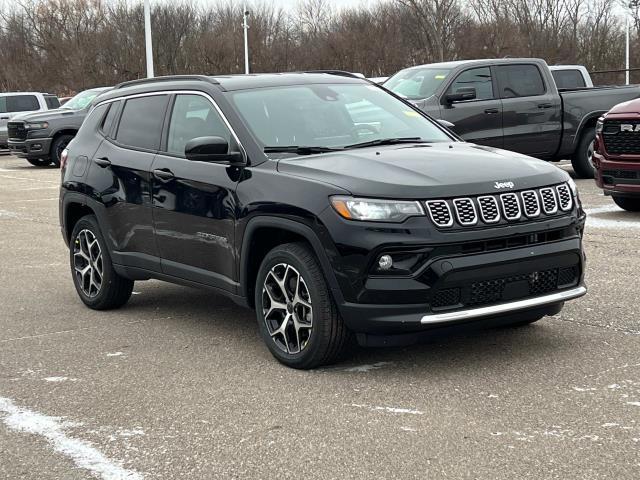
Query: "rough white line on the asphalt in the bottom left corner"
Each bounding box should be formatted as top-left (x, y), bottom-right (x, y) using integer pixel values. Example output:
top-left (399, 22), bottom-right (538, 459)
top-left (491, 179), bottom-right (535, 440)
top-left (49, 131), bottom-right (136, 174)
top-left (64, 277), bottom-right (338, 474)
top-left (0, 397), bottom-right (143, 480)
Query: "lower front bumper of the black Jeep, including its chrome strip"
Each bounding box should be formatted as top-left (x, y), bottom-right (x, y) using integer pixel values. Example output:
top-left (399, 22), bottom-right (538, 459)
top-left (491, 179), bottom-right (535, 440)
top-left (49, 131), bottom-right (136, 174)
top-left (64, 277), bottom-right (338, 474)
top-left (340, 237), bottom-right (586, 338)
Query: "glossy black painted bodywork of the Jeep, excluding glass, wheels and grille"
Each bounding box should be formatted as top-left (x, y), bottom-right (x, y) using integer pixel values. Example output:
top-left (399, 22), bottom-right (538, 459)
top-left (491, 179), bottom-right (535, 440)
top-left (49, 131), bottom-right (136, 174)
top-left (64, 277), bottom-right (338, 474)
top-left (60, 74), bottom-right (584, 340)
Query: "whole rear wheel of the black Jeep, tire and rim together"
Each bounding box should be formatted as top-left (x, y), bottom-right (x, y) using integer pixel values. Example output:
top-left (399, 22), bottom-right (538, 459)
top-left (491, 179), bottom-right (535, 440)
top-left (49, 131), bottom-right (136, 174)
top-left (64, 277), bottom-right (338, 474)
top-left (69, 215), bottom-right (133, 310)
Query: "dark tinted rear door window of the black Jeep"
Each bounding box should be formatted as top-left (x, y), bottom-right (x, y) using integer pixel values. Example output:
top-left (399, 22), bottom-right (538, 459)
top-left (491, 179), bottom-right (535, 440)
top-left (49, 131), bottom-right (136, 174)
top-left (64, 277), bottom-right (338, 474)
top-left (116, 95), bottom-right (168, 150)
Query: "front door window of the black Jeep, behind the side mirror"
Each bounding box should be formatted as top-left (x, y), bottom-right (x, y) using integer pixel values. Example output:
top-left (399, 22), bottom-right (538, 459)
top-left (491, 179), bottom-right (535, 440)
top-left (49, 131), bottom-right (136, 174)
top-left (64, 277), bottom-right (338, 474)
top-left (167, 95), bottom-right (231, 157)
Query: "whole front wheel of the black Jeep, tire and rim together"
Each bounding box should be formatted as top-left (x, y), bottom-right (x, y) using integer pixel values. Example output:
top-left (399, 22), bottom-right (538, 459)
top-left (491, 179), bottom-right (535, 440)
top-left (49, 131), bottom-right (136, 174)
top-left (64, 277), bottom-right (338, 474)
top-left (255, 243), bottom-right (351, 369)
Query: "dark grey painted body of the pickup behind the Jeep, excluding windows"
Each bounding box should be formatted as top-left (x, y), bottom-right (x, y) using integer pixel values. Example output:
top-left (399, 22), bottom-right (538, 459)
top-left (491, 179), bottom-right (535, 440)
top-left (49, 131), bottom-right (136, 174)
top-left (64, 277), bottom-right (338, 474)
top-left (404, 58), bottom-right (640, 160)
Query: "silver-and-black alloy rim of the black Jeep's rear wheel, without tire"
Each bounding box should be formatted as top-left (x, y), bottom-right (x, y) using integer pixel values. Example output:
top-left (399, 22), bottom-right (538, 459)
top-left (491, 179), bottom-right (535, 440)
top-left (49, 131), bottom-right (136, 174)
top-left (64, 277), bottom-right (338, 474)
top-left (73, 229), bottom-right (103, 298)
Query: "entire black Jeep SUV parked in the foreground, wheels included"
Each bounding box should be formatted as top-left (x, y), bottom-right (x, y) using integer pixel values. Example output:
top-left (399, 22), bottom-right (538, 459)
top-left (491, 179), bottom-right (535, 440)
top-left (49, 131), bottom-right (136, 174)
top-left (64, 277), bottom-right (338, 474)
top-left (60, 72), bottom-right (586, 368)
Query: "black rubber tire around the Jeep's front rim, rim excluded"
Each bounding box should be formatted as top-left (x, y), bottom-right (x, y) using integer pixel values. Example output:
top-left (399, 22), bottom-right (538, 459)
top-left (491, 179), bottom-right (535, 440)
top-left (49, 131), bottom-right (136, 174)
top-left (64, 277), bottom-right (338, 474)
top-left (255, 247), bottom-right (331, 368)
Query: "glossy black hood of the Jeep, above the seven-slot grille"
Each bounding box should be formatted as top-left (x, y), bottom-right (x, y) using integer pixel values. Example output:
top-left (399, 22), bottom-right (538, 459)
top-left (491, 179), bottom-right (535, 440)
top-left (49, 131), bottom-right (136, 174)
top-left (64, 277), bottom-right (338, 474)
top-left (278, 142), bottom-right (570, 199)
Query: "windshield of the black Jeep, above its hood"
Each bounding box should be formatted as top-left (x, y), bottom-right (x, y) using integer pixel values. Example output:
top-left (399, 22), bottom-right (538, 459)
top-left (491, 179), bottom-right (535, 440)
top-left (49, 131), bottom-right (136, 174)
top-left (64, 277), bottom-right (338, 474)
top-left (230, 84), bottom-right (452, 151)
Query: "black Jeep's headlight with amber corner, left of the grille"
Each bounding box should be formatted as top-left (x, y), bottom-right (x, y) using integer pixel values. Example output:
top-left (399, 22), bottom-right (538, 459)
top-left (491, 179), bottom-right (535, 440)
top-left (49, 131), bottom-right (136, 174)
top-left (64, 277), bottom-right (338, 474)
top-left (331, 197), bottom-right (424, 222)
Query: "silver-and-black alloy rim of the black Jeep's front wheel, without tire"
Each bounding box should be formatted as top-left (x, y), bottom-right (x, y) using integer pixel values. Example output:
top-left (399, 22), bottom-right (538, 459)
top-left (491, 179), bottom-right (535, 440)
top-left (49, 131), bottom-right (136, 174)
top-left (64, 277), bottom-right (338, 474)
top-left (262, 263), bottom-right (313, 354)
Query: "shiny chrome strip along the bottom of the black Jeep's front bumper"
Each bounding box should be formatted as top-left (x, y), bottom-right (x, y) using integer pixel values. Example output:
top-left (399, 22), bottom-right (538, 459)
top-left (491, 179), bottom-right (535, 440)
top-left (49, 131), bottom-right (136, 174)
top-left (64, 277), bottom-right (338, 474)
top-left (420, 286), bottom-right (587, 324)
